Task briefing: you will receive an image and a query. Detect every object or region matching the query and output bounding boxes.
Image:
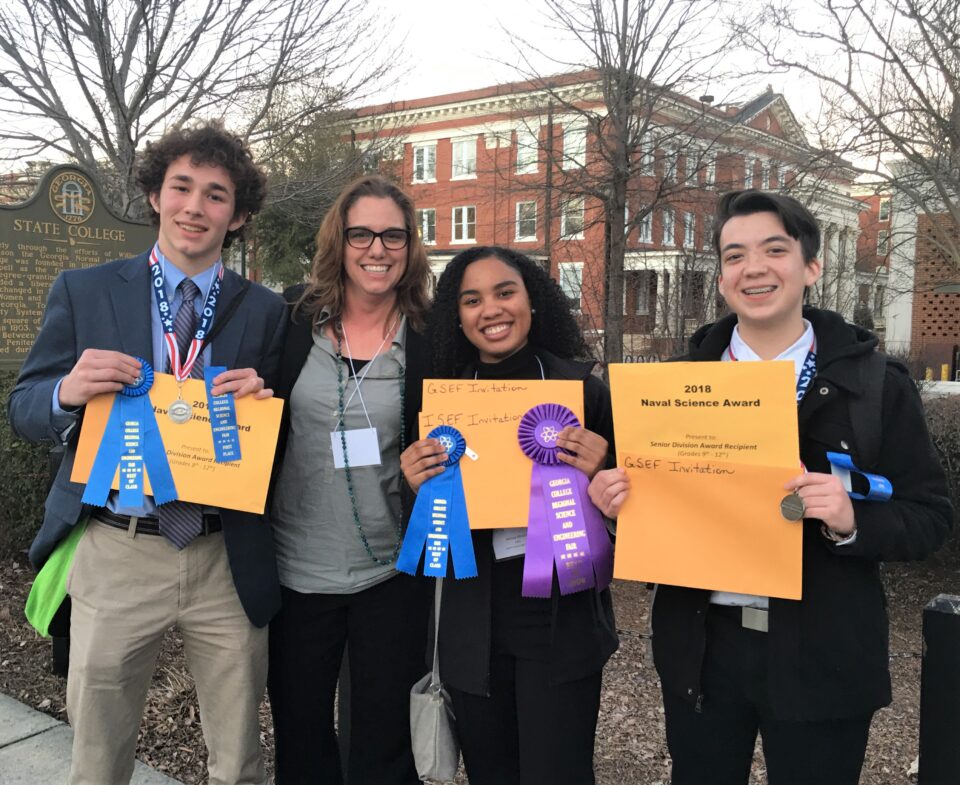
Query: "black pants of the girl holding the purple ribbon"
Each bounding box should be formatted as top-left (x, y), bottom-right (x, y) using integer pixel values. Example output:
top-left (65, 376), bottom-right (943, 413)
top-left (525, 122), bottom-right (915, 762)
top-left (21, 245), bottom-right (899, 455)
top-left (449, 654), bottom-right (601, 785)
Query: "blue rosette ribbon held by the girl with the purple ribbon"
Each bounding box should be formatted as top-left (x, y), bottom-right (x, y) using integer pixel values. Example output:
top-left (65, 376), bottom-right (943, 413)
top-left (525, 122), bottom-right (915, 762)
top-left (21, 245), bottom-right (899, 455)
top-left (397, 425), bottom-right (477, 578)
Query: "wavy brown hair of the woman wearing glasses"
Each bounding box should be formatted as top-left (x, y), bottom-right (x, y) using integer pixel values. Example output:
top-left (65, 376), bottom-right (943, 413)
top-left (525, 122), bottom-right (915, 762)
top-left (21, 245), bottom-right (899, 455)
top-left (295, 175), bottom-right (430, 332)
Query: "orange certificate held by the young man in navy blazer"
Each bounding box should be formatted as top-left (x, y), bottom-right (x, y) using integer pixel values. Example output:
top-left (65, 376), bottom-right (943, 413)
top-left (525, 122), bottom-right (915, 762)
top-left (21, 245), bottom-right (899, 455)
top-left (70, 373), bottom-right (283, 513)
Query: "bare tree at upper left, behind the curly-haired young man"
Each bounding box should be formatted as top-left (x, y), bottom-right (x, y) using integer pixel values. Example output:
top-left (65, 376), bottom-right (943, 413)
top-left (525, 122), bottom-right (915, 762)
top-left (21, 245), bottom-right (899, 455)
top-left (0, 0), bottom-right (388, 215)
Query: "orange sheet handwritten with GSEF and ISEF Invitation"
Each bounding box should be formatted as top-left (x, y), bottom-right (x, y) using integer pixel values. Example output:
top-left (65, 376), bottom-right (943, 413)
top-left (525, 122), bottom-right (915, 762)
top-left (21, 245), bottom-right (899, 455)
top-left (420, 379), bottom-right (583, 529)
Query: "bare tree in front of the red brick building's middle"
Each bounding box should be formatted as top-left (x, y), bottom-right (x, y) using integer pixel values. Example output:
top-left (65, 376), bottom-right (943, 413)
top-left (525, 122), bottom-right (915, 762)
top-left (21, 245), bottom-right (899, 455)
top-left (502, 0), bottom-right (752, 362)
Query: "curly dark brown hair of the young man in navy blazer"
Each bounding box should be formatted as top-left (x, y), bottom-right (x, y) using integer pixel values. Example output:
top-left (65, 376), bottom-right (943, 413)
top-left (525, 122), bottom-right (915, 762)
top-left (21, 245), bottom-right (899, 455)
top-left (137, 121), bottom-right (267, 248)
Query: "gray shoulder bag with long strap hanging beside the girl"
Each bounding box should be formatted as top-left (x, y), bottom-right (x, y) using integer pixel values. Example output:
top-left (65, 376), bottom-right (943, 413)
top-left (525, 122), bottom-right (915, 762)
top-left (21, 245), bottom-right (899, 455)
top-left (410, 578), bottom-right (460, 782)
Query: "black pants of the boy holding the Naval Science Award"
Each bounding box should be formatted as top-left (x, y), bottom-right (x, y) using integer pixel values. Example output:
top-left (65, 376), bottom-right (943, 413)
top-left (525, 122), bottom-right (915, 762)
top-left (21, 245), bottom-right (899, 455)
top-left (663, 606), bottom-right (873, 785)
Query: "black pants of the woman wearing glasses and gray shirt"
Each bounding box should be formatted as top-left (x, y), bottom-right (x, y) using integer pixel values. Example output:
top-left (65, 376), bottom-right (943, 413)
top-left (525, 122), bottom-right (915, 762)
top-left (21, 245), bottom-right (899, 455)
top-left (267, 575), bottom-right (432, 785)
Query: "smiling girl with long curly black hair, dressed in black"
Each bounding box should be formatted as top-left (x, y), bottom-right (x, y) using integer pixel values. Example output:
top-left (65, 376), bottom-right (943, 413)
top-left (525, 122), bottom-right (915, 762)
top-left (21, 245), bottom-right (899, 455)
top-left (400, 247), bottom-right (617, 785)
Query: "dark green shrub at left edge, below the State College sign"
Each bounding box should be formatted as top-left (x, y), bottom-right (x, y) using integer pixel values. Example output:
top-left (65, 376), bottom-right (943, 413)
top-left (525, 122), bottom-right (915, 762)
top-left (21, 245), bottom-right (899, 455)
top-left (0, 371), bottom-right (49, 556)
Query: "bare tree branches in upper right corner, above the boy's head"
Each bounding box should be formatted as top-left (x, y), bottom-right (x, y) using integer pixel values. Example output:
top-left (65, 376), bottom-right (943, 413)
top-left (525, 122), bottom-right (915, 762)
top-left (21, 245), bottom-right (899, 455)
top-left (733, 0), bottom-right (960, 268)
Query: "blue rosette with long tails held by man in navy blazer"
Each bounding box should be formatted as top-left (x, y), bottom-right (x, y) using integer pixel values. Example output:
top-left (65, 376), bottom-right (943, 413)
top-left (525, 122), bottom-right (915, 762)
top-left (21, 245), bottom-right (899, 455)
top-left (83, 357), bottom-right (177, 507)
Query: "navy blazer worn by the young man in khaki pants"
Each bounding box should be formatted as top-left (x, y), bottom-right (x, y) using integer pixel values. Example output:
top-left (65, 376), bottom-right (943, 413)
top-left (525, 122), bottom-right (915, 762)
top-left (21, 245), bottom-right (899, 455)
top-left (8, 253), bottom-right (286, 627)
